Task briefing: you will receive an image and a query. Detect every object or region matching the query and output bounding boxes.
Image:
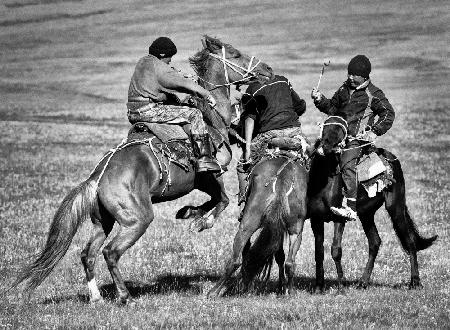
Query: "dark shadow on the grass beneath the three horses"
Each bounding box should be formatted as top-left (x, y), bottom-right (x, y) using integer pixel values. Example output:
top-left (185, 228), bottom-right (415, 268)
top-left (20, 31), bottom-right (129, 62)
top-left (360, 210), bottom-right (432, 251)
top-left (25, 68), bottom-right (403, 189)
top-left (43, 273), bottom-right (408, 305)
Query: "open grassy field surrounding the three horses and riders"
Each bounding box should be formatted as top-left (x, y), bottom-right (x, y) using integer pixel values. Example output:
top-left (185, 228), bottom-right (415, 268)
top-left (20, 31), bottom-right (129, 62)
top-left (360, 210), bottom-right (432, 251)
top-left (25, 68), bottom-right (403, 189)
top-left (0, 0), bottom-right (450, 329)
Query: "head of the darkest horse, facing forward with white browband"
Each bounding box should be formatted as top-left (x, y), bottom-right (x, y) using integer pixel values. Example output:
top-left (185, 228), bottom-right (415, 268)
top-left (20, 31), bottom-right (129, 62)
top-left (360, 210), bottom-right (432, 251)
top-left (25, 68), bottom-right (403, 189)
top-left (315, 116), bottom-right (348, 156)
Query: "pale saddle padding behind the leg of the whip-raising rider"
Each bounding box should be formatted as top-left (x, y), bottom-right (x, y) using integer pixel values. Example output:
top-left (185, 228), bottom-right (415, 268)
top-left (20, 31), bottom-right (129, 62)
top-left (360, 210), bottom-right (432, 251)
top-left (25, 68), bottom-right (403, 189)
top-left (356, 148), bottom-right (395, 198)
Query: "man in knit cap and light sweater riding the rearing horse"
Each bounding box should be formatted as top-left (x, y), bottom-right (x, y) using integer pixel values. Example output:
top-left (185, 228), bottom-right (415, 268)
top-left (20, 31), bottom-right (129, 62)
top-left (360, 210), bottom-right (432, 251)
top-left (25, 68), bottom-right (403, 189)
top-left (127, 37), bottom-right (221, 172)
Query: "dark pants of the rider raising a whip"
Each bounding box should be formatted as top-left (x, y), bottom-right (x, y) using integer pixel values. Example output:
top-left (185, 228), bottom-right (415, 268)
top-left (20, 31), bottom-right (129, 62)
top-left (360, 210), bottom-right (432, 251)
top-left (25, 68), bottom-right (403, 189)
top-left (340, 140), bottom-right (366, 207)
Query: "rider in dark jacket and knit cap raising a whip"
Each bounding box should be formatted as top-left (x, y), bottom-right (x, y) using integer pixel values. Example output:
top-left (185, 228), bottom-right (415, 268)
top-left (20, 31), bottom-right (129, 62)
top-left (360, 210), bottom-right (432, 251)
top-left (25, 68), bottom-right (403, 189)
top-left (311, 55), bottom-right (395, 221)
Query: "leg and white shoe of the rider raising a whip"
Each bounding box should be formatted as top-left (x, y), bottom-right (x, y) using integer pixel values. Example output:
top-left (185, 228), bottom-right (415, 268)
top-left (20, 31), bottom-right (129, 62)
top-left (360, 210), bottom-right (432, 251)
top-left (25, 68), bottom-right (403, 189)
top-left (331, 140), bottom-right (361, 221)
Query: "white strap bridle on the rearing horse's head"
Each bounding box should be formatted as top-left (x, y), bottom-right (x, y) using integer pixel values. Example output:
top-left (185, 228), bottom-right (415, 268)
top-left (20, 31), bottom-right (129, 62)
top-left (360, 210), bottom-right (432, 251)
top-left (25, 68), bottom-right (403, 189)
top-left (198, 46), bottom-right (261, 93)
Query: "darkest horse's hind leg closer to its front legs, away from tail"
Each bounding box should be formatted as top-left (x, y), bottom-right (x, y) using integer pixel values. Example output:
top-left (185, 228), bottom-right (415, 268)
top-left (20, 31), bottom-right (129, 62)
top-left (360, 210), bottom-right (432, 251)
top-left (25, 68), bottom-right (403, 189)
top-left (359, 214), bottom-right (381, 288)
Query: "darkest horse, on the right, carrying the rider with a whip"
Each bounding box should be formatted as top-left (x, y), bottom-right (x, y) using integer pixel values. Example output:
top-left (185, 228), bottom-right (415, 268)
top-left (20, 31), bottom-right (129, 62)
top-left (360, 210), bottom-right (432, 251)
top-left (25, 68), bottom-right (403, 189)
top-left (308, 116), bottom-right (437, 291)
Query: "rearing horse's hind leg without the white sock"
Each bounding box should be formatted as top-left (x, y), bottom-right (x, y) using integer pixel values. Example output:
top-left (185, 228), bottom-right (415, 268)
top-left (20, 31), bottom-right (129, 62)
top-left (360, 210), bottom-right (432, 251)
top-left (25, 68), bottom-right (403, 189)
top-left (103, 201), bottom-right (154, 304)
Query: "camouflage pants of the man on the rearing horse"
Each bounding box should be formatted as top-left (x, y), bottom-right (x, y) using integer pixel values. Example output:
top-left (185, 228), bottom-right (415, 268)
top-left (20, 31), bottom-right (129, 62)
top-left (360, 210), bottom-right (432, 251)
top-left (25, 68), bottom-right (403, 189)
top-left (127, 102), bottom-right (208, 135)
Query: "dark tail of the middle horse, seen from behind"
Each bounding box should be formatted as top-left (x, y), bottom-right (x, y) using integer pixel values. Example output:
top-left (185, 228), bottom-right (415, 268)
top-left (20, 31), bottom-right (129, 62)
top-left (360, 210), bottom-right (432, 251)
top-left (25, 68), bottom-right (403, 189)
top-left (242, 176), bottom-right (290, 283)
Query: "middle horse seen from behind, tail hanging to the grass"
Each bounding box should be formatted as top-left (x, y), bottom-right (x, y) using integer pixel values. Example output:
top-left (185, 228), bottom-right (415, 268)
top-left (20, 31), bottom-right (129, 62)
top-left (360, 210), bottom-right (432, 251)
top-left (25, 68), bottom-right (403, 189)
top-left (208, 149), bottom-right (308, 297)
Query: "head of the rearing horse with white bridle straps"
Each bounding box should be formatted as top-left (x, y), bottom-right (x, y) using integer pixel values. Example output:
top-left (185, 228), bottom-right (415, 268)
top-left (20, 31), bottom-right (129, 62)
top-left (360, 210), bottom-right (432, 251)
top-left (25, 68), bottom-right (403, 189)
top-left (190, 36), bottom-right (273, 89)
